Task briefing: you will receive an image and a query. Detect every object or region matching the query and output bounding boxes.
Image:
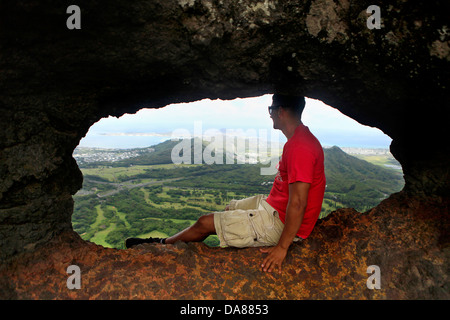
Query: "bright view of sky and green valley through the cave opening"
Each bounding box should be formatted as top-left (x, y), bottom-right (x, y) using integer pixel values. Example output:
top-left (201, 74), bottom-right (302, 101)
top-left (72, 95), bottom-right (404, 249)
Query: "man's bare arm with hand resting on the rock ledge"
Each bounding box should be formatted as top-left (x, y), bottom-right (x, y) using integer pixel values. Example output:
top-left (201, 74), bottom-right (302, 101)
top-left (261, 181), bottom-right (310, 272)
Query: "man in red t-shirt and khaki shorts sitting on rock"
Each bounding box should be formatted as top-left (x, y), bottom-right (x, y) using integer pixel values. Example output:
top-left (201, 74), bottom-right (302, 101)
top-left (125, 94), bottom-right (325, 272)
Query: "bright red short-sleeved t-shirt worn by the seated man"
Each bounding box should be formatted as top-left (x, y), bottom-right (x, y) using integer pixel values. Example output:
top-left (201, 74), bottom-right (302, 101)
top-left (266, 124), bottom-right (325, 239)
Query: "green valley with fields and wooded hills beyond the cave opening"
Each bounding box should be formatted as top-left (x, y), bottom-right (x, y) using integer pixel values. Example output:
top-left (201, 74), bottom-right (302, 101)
top-left (72, 141), bottom-right (404, 248)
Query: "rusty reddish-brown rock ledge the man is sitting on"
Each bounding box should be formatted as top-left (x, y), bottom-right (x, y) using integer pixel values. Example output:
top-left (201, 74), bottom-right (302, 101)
top-left (0, 193), bottom-right (450, 300)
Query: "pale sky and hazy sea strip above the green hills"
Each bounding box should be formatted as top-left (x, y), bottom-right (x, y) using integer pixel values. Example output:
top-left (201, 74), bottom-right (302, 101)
top-left (79, 95), bottom-right (392, 148)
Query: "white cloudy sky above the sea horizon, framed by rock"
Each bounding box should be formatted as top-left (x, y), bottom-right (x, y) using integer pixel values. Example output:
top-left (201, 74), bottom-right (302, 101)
top-left (82, 95), bottom-right (391, 147)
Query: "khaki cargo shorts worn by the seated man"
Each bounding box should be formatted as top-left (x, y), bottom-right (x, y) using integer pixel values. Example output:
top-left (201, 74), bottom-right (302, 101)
top-left (214, 195), bottom-right (284, 248)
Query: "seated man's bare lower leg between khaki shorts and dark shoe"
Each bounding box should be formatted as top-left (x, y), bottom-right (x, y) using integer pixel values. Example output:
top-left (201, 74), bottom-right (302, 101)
top-left (165, 213), bottom-right (216, 244)
